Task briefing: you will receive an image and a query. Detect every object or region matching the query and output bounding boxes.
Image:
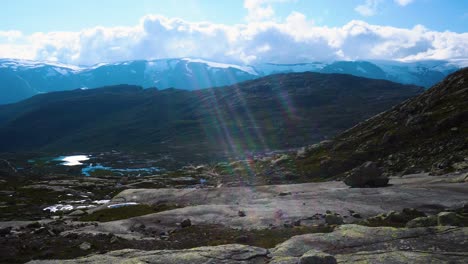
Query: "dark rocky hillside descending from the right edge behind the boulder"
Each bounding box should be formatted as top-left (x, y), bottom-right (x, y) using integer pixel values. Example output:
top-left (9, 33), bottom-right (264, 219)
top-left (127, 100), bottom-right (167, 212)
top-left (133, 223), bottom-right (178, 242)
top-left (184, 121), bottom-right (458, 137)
top-left (288, 68), bottom-right (468, 177)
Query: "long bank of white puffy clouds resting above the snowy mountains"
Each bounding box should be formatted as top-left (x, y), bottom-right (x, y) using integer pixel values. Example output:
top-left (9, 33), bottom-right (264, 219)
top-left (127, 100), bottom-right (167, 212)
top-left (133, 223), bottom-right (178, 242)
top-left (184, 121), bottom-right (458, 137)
top-left (0, 12), bottom-right (468, 65)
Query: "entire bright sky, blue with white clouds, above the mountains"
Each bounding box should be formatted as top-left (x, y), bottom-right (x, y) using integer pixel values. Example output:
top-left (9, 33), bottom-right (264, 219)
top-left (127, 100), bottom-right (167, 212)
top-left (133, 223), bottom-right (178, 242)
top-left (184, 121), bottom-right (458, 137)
top-left (0, 0), bottom-right (468, 65)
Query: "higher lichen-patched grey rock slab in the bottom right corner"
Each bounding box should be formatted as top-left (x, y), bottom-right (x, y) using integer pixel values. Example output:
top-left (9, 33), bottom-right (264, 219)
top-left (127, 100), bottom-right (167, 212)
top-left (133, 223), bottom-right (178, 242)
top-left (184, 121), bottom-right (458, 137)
top-left (270, 225), bottom-right (468, 264)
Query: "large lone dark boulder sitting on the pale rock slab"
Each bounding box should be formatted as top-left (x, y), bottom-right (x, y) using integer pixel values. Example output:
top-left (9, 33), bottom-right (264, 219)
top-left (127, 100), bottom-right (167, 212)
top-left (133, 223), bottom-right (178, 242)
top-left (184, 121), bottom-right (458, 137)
top-left (343, 161), bottom-right (389, 188)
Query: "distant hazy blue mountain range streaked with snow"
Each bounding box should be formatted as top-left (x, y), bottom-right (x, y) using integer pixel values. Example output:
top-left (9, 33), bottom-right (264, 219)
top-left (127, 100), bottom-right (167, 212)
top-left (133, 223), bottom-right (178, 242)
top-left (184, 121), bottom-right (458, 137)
top-left (0, 58), bottom-right (465, 104)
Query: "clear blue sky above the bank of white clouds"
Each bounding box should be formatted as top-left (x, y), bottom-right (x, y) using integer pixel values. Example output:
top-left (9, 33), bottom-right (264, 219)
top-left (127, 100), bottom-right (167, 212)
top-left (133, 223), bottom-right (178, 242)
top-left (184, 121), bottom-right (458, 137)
top-left (4, 0), bottom-right (468, 33)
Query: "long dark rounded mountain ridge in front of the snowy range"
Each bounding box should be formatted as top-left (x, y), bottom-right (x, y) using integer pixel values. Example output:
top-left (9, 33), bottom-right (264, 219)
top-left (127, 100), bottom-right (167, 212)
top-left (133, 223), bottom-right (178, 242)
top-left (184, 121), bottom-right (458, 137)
top-left (0, 73), bottom-right (422, 162)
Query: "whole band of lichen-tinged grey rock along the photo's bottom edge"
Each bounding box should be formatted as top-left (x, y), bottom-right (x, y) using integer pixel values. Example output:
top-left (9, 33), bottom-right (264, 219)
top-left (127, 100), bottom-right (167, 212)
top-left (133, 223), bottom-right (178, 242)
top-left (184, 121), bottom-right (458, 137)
top-left (29, 225), bottom-right (468, 264)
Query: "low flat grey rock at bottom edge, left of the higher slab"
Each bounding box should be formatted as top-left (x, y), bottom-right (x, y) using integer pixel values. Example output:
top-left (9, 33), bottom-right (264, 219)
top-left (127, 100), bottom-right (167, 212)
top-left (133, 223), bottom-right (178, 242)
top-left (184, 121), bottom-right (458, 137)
top-left (29, 244), bottom-right (268, 264)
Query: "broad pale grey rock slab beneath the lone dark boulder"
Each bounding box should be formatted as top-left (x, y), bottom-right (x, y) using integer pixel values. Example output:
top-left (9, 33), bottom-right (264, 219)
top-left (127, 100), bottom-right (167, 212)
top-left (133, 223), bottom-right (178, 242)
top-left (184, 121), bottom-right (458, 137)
top-left (82, 174), bottom-right (468, 235)
